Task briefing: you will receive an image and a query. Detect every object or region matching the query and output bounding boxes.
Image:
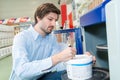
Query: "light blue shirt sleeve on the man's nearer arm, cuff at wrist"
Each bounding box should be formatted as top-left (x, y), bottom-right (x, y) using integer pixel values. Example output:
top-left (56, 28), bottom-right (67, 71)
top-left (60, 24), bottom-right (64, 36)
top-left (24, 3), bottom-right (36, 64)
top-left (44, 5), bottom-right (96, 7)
top-left (12, 35), bottom-right (52, 80)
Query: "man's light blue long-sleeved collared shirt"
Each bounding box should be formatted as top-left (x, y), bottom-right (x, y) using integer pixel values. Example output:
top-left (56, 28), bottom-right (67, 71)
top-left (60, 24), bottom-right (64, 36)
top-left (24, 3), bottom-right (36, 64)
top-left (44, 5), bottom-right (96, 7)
top-left (9, 26), bottom-right (65, 80)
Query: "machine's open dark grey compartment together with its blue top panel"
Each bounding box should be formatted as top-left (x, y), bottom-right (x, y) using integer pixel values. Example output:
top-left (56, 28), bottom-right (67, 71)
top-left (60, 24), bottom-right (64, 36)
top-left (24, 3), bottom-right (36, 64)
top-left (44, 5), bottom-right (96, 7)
top-left (80, 0), bottom-right (110, 69)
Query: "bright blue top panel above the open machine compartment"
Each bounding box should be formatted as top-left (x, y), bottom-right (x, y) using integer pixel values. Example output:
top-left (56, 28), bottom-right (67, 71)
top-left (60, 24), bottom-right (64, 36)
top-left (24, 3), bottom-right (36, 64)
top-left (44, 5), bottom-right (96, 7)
top-left (80, 0), bottom-right (110, 27)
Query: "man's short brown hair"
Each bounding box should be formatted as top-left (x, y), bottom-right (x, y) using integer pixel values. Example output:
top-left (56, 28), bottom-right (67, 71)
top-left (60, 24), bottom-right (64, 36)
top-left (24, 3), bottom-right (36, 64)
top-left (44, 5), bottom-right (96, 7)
top-left (34, 3), bottom-right (60, 24)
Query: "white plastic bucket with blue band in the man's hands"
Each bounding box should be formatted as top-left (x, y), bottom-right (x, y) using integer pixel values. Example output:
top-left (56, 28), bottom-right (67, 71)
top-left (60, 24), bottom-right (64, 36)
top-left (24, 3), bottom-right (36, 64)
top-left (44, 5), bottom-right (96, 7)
top-left (66, 55), bottom-right (92, 80)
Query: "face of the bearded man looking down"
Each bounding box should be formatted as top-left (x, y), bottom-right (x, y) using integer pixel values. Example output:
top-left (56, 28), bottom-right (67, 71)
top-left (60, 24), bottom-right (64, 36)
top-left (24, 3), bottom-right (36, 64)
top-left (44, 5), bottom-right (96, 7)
top-left (38, 12), bottom-right (58, 34)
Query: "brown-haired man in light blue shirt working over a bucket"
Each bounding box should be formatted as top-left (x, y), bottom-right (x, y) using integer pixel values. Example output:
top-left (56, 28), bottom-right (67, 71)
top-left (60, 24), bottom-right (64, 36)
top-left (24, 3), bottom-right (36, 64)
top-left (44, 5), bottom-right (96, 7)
top-left (10, 3), bottom-right (94, 80)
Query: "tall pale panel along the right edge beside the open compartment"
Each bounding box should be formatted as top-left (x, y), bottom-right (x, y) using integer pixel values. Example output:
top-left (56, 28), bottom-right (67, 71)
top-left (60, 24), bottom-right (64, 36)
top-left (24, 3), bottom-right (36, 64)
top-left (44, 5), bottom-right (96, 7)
top-left (105, 0), bottom-right (120, 80)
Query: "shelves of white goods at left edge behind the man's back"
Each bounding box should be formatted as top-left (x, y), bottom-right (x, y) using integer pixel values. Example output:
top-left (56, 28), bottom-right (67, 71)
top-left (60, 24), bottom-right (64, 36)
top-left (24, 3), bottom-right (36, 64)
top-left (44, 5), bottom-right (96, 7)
top-left (0, 25), bottom-right (14, 59)
